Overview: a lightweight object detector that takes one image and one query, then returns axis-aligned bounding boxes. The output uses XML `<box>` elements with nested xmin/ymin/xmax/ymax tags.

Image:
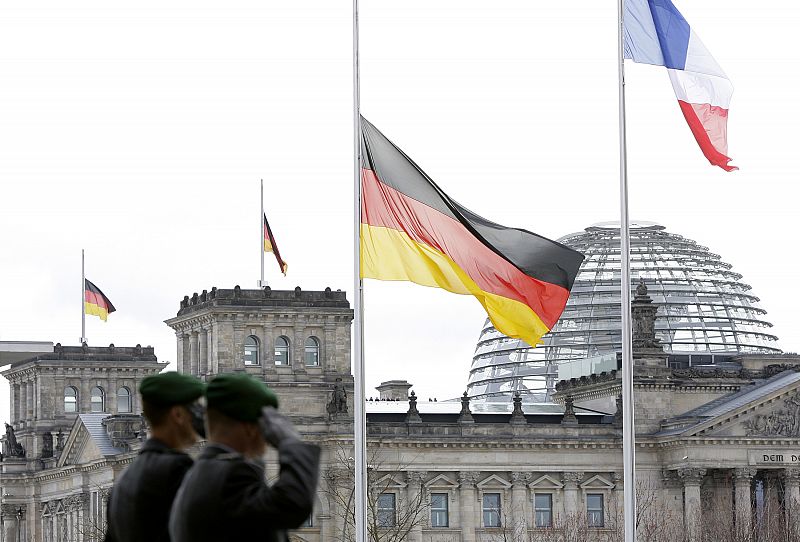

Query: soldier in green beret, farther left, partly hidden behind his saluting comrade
<box><xmin>105</xmin><ymin>372</ymin><xmax>205</xmax><ymax>542</ymax></box>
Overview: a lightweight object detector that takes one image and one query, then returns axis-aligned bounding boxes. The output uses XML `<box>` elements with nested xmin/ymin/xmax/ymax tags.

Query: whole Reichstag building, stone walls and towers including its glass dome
<box><xmin>0</xmin><ymin>223</ymin><xmax>800</xmax><ymax>542</ymax></box>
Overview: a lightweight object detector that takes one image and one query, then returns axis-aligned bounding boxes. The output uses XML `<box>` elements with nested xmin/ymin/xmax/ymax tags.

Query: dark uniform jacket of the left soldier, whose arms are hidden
<box><xmin>106</xmin><ymin>439</ymin><xmax>192</xmax><ymax>542</ymax></box>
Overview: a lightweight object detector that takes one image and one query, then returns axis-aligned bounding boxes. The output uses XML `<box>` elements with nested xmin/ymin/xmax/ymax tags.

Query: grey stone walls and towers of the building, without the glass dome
<box><xmin>7</xmin><ymin>287</ymin><xmax>800</xmax><ymax>542</ymax></box>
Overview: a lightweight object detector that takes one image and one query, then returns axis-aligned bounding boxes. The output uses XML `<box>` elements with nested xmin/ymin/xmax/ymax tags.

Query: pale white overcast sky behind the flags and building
<box><xmin>0</xmin><ymin>0</ymin><xmax>800</xmax><ymax>419</ymax></box>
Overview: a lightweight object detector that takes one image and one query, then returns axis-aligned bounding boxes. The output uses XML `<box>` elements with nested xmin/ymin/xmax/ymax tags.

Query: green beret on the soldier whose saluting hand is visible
<box><xmin>206</xmin><ymin>373</ymin><xmax>278</xmax><ymax>422</ymax></box>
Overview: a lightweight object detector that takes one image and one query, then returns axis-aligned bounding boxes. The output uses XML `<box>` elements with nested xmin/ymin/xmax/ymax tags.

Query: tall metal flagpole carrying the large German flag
<box><xmin>353</xmin><ymin>0</ymin><xmax>367</xmax><ymax>542</ymax></box>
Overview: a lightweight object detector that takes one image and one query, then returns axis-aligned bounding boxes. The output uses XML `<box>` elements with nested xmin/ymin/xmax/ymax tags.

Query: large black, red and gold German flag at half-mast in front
<box><xmin>361</xmin><ymin>117</ymin><xmax>583</xmax><ymax>346</ymax></box>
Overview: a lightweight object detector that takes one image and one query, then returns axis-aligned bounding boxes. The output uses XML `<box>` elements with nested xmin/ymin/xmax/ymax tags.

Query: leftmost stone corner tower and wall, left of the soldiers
<box><xmin>0</xmin><ymin>344</ymin><xmax>166</xmax><ymax>542</ymax></box>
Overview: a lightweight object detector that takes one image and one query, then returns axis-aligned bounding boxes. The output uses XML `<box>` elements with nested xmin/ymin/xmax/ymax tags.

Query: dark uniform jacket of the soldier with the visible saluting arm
<box><xmin>169</xmin><ymin>441</ymin><xmax>320</xmax><ymax>542</ymax></box>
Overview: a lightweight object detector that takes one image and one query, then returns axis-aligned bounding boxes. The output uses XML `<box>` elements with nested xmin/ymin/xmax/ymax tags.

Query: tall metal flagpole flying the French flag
<box><xmin>617</xmin><ymin>0</ymin><xmax>636</xmax><ymax>542</ymax></box>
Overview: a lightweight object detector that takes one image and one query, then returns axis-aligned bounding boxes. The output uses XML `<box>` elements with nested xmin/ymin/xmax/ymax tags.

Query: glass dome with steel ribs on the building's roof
<box><xmin>467</xmin><ymin>222</ymin><xmax>780</xmax><ymax>402</ymax></box>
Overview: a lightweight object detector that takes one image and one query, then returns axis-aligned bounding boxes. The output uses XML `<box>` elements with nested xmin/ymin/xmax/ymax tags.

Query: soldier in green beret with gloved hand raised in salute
<box><xmin>169</xmin><ymin>373</ymin><xmax>320</xmax><ymax>542</ymax></box>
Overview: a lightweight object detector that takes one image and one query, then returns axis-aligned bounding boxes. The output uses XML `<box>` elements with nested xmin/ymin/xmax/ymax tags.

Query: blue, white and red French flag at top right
<box><xmin>624</xmin><ymin>0</ymin><xmax>738</xmax><ymax>171</ymax></box>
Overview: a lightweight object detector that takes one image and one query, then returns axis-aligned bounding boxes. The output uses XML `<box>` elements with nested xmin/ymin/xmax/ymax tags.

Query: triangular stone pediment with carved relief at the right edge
<box><xmin>656</xmin><ymin>372</ymin><xmax>800</xmax><ymax>439</ymax></box>
